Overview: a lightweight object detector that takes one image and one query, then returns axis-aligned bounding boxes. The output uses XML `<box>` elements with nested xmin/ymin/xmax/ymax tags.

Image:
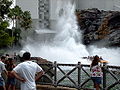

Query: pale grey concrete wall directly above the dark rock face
<box><xmin>77</xmin><ymin>0</ymin><xmax>120</xmax><ymax>10</ymax></box>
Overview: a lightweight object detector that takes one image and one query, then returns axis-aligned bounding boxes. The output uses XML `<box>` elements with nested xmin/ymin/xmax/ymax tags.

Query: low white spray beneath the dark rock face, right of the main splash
<box><xmin>88</xmin><ymin>45</ymin><xmax>120</xmax><ymax>66</ymax></box>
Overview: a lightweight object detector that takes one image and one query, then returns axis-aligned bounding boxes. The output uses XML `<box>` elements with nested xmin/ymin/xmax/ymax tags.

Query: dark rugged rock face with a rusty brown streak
<box><xmin>76</xmin><ymin>8</ymin><xmax>120</xmax><ymax>47</ymax></box>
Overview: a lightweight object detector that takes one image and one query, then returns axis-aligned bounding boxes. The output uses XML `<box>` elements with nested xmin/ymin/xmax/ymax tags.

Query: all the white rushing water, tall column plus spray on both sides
<box><xmin>23</xmin><ymin>0</ymin><xmax>120</xmax><ymax>65</ymax></box>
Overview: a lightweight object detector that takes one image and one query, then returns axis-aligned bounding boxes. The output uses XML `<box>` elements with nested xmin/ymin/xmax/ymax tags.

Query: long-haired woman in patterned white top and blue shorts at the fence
<box><xmin>90</xmin><ymin>55</ymin><xmax>103</xmax><ymax>90</ymax></box>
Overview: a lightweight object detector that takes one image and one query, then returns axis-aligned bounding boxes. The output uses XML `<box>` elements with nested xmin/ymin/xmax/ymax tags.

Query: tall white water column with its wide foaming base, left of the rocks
<box><xmin>23</xmin><ymin>0</ymin><xmax>89</xmax><ymax>63</ymax></box>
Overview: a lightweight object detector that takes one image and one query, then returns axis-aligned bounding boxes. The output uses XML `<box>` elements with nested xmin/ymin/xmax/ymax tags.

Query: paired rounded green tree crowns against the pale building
<box><xmin>8</xmin><ymin>6</ymin><xmax>32</xmax><ymax>30</ymax></box>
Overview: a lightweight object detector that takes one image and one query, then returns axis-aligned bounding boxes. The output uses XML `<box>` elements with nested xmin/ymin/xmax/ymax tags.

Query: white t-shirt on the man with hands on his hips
<box><xmin>17</xmin><ymin>61</ymin><xmax>42</xmax><ymax>90</ymax></box>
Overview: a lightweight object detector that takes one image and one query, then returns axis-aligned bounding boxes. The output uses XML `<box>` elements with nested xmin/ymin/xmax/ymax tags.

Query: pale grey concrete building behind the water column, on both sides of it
<box><xmin>16</xmin><ymin>0</ymin><xmax>120</xmax><ymax>29</ymax></box>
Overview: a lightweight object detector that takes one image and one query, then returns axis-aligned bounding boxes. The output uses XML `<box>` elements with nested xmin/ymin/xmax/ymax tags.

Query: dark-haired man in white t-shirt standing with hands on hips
<box><xmin>12</xmin><ymin>52</ymin><xmax>44</xmax><ymax>90</ymax></box>
